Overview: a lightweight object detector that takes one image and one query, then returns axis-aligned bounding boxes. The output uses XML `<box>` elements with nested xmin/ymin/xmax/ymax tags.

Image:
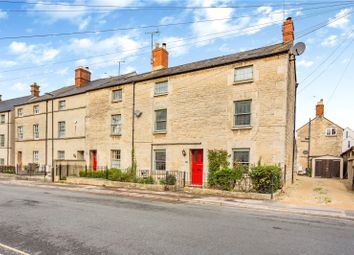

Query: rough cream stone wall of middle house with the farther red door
<box><xmin>86</xmin><ymin>85</ymin><xmax>133</xmax><ymax>168</ymax></box>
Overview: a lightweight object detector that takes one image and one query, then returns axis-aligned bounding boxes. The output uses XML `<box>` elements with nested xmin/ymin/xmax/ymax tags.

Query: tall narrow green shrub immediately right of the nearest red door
<box><xmin>208</xmin><ymin>150</ymin><xmax>229</xmax><ymax>187</ymax></box>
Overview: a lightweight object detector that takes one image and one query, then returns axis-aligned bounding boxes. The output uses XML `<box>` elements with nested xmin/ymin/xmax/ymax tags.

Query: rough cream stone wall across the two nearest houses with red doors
<box><xmin>86</xmin><ymin>54</ymin><xmax>295</xmax><ymax>183</ymax></box>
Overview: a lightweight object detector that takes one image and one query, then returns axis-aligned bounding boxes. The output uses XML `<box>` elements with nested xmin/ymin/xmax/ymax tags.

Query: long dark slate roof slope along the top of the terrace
<box><xmin>18</xmin><ymin>43</ymin><xmax>292</xmax><ymax>105</ymax></box>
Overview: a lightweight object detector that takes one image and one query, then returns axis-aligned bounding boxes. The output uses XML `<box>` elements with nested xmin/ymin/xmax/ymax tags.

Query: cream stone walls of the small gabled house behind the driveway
<box><xmin>297</xmin><ymin>117</ymin><xmax>343</xmax><ymax>169</ymax></box>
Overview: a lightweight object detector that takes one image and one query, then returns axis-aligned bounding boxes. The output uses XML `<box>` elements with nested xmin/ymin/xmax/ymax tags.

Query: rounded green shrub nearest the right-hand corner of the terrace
<box><xmin>250</xmin><ymin>165</ymin><xmax>281</xmax><ymax>193</ymax></box>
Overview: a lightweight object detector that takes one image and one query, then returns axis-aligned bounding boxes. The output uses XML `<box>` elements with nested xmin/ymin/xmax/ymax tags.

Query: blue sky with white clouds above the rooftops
<box><xmin>0</xmin><ymin>0</ymin><xmax>354</xmax><ymax>128</ymax></box>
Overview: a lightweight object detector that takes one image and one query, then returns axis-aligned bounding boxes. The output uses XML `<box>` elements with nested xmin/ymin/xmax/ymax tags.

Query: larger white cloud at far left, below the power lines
<box><xmin>9</xmin><ymin>41</ymin><xmax>60</xmax><ymax>64</ymax></box>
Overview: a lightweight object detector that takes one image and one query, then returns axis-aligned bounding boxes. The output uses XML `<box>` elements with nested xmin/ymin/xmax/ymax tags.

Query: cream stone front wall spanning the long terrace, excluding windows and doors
<box><xmin>11</xmin><ymin>51</ymin><xmax>295</xmax><ymax>183</ymax></box>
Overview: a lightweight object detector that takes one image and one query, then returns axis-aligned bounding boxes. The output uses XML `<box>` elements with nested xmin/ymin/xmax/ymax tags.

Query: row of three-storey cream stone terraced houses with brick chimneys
<box><xmin>0</xmin><ymin>18</ymin><xmax>296</xmax><ymax>185</ymax></box>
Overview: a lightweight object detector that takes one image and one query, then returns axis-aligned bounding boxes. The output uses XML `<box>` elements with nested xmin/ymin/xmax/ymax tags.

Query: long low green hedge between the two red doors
<box><xmin>79</xmin><ymin>169</ymin><xmax>155</xmax><ymax>184</ymax></box>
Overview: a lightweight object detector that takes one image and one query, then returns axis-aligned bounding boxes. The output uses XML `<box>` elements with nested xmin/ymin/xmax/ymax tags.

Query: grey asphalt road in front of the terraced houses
<box><xmin>0</xmin><ymin>184</ymin><xmax>354</xmax><ymax>255</ymax></box>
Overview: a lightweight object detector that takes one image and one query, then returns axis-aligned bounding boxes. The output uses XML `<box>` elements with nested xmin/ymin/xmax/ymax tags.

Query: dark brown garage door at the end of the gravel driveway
<box><xmin>315</xmin><ymin>159</ymin><xmax>340</xmax><ymax>178</ymax></box>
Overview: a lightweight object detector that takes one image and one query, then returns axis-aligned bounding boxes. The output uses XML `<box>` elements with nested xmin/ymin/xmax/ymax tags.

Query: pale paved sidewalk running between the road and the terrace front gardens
<box><xmin>0</xmin><ymin>179</ymin><xmax>354</xmax><ymax>220</ymax></box>
